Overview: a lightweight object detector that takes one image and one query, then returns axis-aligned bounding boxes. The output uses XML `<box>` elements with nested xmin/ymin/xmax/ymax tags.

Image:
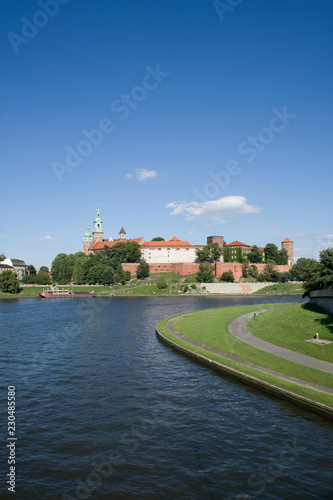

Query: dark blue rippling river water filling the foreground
<box><xmin>0</xmin><ymin>297</ymin><xmax>333</xmax><ymax>500</ymax></box>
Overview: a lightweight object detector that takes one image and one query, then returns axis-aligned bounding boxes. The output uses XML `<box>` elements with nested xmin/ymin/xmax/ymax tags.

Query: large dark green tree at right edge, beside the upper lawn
<box><xmin>303</xmin><ymin>248</ymin><xmax>333</xmax><ymax>295</ymax></box>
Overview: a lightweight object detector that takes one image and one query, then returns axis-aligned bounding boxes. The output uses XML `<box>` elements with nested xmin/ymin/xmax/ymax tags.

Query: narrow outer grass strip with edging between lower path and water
<box><xmin>156</xmin><ymin>311</ymin><xmax>333</xmax><ymax>420</ymax></box>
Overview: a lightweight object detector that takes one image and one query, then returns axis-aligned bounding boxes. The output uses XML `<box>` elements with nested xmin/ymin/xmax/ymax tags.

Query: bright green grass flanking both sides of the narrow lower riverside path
<box><xmin>157</xmin><ymin>304</ymin><xmax>333</xmax><ymax>407</ymax></box>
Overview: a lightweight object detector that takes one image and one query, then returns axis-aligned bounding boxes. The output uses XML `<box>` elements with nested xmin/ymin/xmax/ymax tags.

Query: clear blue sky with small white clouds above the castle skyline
<box><xmin>0</xmin><ymin>0</ymin><xmax>333</xmax><ymax>267</ymax></box>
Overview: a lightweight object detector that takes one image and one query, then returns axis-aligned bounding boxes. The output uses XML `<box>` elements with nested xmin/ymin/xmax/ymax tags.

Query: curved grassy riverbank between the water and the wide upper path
<box><xmin>157</xmin><ymin>304</ymin><xmax>333</xmax><ymax>419</ymax></box>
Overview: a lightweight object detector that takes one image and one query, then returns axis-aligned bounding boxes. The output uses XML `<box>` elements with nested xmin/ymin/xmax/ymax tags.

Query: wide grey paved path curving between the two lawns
<box><xmin>229</xmin><ymin>307</ymin><xmax>333</xmax><ymax>375</ymax></box>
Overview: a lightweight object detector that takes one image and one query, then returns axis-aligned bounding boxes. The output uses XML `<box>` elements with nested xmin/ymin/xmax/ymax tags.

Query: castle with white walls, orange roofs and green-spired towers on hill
<box><xmin>83</xmin><ymin>207</ymin><xmax>293</xmax><ymax>270</ymax></box>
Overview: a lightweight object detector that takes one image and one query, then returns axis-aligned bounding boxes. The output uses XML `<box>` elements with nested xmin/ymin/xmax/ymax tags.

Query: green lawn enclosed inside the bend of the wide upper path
<box><xmin>248</xmin><ymin>304</ymin><xmax>333</xmax><ymax>363</ymax></box>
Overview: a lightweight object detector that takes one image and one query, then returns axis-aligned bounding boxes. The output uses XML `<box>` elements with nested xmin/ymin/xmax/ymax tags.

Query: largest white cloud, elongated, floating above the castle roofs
<box><xmin>166</xmin><ymin>196</ymin><xmax>261</xmax><ymax>224</ymax></box>
